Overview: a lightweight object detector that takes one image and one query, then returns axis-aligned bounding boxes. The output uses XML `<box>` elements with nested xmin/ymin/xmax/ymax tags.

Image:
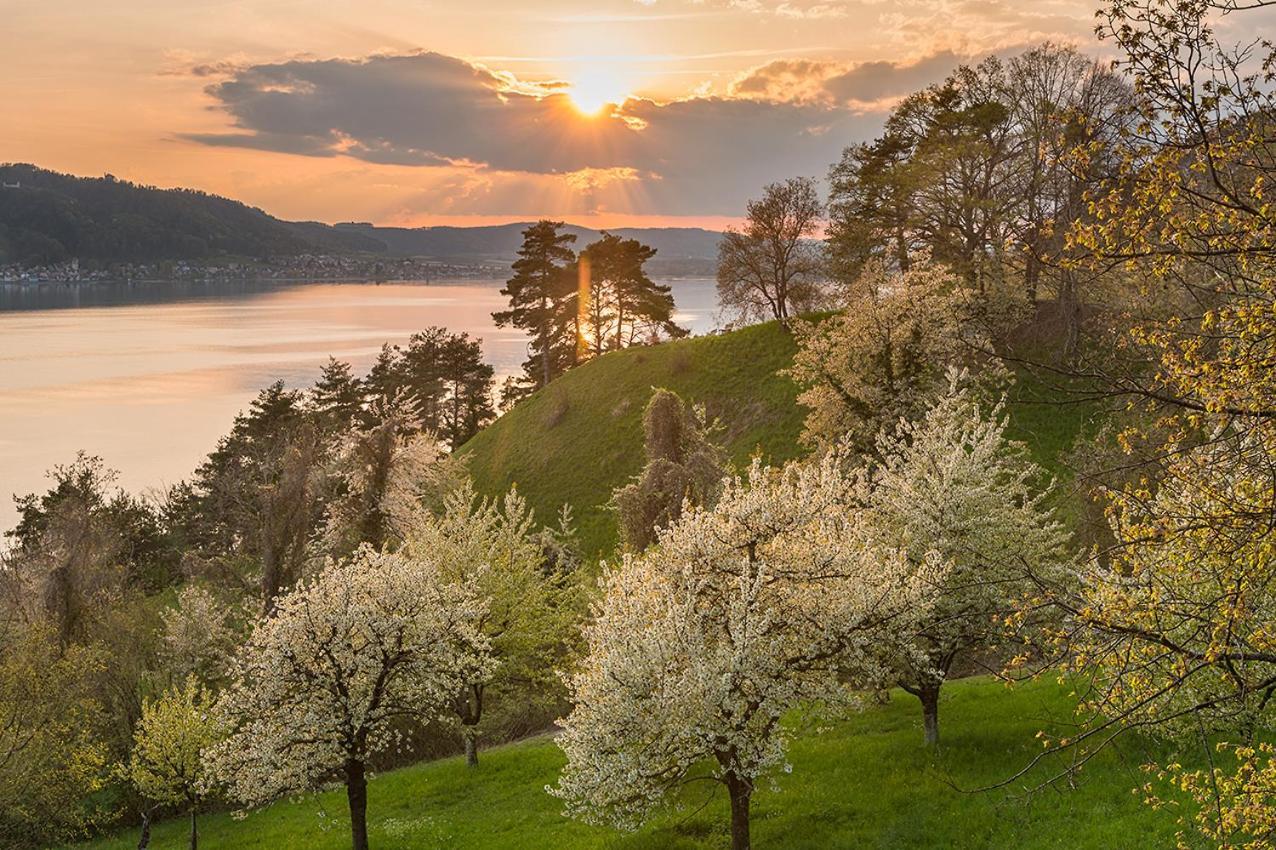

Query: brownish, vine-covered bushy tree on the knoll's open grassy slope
<box><xmin>611</xmin><ymin>389</ymin><xmax>726</xmax><ymax>551</ymax></box>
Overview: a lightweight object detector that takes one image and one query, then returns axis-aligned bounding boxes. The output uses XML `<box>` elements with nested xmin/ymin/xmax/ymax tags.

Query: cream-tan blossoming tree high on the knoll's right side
<box><xmin>790</xmin><ymin>260</ymin><xmax>997</xmax><ymax>452</ymax></box>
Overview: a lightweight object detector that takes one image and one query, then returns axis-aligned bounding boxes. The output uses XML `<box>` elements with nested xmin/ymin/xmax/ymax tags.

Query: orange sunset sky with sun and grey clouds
<box><xmin>0</xmin><ymin>0</ymin><xmax>1102</xmax><ymax>227</ymax></box>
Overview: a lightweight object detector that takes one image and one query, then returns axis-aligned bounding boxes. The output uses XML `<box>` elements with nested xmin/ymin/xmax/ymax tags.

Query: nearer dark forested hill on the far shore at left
<box><xmin>0</xmin><ymin>165</ymin><xmax>385</xmax><ymax>265</ymax></box>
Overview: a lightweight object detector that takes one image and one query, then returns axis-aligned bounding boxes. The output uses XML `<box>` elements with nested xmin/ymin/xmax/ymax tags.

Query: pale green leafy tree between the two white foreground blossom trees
<box><xmin>406</xmin><ymin>481</ymin><xmax>575</xmax><ymax>767</ymax></box>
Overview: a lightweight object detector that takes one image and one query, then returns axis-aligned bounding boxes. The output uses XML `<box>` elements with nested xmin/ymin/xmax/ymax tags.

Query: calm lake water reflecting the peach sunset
<box><xmin>0</xmin><ymin>281</ymin><xmax>716</xmax><ymax>528</ymax></box>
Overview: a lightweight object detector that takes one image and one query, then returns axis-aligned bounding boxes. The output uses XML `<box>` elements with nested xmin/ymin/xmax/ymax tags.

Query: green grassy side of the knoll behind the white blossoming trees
<box><xmin>462</xmin><ymin>317</ymin><xmax>1085</xmax><ymax>555</ymax></box>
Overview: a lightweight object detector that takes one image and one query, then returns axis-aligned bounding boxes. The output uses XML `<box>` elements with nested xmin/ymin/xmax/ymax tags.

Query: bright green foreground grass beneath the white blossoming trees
<box><xmin>69</xmin><ymin>679</ymin><xmax>1176</xmax><ymax>850</ymax></box>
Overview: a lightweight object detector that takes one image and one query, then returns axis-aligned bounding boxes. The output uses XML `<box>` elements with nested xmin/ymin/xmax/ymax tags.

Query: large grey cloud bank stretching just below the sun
<box><xmin>181</xmin><ymin>52</ymin><xmax>882</xmax><ymax>214</ymax></box>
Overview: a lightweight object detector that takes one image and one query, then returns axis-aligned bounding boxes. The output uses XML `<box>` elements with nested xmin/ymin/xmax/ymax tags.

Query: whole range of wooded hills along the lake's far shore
<box><xmin>0</xmin><ymin>163</ymin><xmax>718</xmax><ymax>274</ymax></box>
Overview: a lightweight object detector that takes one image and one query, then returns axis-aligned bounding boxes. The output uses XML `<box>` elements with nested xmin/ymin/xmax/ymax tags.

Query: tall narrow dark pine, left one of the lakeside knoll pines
<box><xmin>491</xmin><ymin>220</ymin><xmax>577</xmax><ymax>391</ymax></box>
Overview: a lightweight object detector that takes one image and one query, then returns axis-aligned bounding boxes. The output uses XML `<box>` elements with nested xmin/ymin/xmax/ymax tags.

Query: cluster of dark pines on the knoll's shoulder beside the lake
<box><xmin>493</xmin><ymin>220</ymin><xmax>686</xmax><ymax>402</ymax></box>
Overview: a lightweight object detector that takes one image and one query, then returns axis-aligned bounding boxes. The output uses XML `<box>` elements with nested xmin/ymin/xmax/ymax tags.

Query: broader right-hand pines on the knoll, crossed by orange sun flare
<box><xmin>577</xmin><ymin>234</ymin><xmax>686</xmax><ymax>357</ymax></box>
